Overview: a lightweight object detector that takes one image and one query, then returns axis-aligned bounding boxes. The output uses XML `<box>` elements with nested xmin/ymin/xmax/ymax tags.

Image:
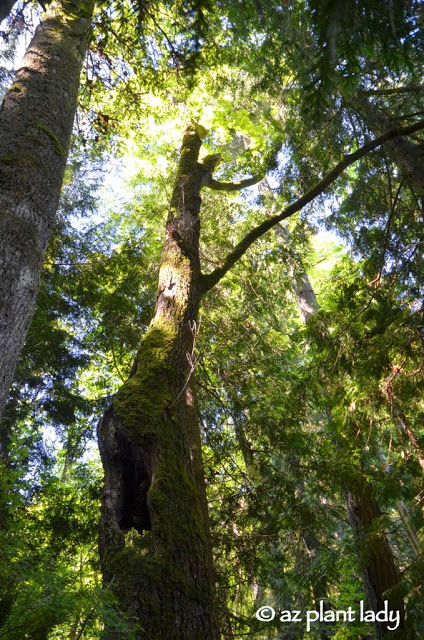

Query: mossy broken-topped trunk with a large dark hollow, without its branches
<box><xmin>98</xmin><ymin>125</ymin><xmax>219</xmax><ymax>640</ymax></box>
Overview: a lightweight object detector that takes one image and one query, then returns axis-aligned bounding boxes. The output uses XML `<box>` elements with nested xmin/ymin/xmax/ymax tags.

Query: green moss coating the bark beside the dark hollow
<box><xmin>109</xmin><ymin>317</ymin><xmax>210</xmax><ymax>601</ymax></box>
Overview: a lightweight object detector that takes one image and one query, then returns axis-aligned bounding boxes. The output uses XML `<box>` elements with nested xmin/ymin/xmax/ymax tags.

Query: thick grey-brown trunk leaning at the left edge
<box><xmin>0</xmin><ymin>0</ymin><xmax>93</xmax><ymax>416</ymax></box>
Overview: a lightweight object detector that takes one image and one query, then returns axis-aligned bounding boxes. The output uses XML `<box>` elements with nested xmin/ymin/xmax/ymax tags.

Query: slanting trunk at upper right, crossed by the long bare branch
<box><xmin>349</xmin><ymin>94</ymin><xmax>424</xmax><ymax>198</ymax></box>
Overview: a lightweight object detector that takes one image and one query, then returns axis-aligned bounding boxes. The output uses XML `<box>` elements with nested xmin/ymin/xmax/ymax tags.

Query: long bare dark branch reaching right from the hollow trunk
<box><xmin>201</xmin><ymin>120</ymin><xmax>424</xmax><ymax>294</ymax></box>
